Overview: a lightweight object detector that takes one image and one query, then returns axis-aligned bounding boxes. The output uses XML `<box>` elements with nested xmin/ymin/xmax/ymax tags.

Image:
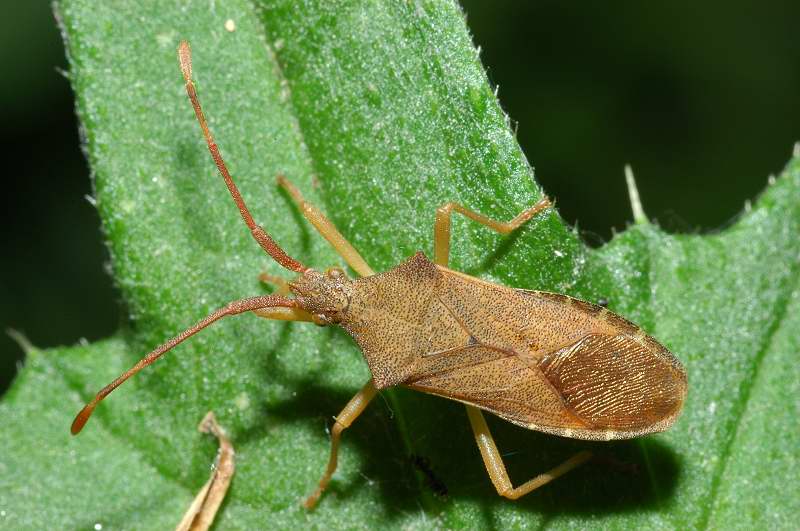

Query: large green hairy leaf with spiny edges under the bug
<box><xmin>0</xmin><ymin>0</ymin><xmax>800</xmax><ymax>529</ymax></box>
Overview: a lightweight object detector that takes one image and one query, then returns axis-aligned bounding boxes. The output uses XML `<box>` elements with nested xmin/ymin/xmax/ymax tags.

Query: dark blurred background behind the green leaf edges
<box><xmin>0</xmin><ymin>0</ymin><xmax>800</xmax><ymax>393</ymax></box>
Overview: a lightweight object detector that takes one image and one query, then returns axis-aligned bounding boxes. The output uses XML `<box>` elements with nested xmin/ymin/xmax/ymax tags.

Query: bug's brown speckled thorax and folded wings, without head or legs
<box><xmin>352</xmin><ymin>264</ymin><xmax>686</xmax><ymax>439</ymax></box>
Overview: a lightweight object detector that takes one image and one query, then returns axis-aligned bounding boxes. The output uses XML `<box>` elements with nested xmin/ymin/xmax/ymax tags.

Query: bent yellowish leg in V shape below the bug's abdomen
<box><xmin>467</xmin><ymin>406</ymin><xmax>592</xmax><ymax>500</ymax></box>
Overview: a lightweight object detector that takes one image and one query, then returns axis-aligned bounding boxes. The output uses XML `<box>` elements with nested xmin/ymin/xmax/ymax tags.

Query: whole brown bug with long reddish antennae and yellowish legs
<box><xmin>72</xmin><ymin>42</ymin><xmax>687</xmax><ymax>508</ymax></box>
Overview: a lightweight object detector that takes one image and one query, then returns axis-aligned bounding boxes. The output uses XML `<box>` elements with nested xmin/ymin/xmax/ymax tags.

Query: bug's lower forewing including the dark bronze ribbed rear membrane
<box><xmin>405</xmin><ymin>334</ymin><xmax>686</xmax><ymax>440</ymax></box>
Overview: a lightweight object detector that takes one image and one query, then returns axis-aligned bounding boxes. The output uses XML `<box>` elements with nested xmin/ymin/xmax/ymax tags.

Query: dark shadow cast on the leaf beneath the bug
<box><xmin>231</xmin><ymin>378</ymin><xmax>679</xmax><ymax>527</ymax></box>
